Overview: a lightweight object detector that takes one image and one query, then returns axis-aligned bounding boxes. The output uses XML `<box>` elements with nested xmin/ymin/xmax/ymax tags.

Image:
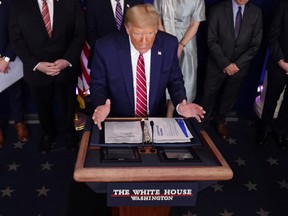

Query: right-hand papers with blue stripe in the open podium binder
<box><xmin>148</xmin><ymin>118</ymin><xmax>193</xmax><ymax>143</ymax></box>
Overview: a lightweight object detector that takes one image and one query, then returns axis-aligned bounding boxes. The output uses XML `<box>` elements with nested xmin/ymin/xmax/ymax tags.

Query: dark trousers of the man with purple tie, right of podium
<box><xmin>200</xmin><ymin>67</ymin><xmax>247</xmax><ymax>124</ymax></box>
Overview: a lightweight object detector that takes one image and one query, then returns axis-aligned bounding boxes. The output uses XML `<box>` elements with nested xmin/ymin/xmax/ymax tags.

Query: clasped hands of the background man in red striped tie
<box><xmin>37</xmin><ymin>59</ymin><xmax>69</xmax><ymax>76</ymax></box>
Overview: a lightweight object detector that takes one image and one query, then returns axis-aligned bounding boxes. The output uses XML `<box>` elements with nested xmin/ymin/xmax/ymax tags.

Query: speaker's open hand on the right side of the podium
<box><xmin>178</xmin><ymin>100</ymin><xmax>206</xmax><ymax>122</ymax></box>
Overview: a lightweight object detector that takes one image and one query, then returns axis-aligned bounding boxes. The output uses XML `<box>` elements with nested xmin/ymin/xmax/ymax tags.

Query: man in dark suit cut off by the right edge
<box><xmin>259</xmin><ymin>0</ymin><xmax>288</xmax><ymax>149</ymax></box>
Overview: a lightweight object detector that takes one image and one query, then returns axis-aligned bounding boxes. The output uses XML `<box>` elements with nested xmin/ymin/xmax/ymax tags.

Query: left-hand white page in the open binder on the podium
<box><xmin>105</xmin><ymin>121</ymin><xmax>142</xmax><ymax>143</ymax></box>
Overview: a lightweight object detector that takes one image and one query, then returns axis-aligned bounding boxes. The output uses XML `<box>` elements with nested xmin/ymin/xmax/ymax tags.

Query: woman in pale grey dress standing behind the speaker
<box><xmin>154</xmin><ymin>0</ymin><xmax>206</xmax><ymax>117</ymax></box>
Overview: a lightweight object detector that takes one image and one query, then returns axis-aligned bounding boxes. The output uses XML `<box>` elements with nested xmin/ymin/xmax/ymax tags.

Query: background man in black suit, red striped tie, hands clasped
<box><xmin>9</xmin><ymin>0</ymin><xmax>85</xmax><ymax>153</ymax></box>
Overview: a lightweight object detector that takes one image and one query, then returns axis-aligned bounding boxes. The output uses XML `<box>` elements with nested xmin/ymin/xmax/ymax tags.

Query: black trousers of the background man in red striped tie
<box><xmin>31</xmin><ymin>82</ymin><xmax>76</xmax><ymax>136</ymax></box>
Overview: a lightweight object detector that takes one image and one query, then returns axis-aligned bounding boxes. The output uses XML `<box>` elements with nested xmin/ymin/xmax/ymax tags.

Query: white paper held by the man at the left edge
<box><xmin>0</xmin><ymin>57</ymin><xmax>23</xmax><ymax>92</ymax></box>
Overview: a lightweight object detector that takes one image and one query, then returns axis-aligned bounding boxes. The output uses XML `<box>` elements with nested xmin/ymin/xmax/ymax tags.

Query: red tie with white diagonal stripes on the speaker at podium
<box><xmin>135</xmin><ymin>53</ymin><xmax>147</xmax><ymax>117</ymax></box>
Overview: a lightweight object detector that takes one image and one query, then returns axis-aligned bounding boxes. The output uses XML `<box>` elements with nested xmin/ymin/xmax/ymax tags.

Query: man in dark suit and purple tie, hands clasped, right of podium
<box><xmin>200</xmin><ymin>0</ymin><xmax>262</xmax><ymax>139</ymax></box>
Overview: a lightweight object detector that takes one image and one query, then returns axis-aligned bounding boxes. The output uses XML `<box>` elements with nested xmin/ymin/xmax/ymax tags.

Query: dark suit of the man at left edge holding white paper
<box><xmin>0</xmin><ymin>0</ymin><xmax>24</xmax><ymax>127</ymax></box>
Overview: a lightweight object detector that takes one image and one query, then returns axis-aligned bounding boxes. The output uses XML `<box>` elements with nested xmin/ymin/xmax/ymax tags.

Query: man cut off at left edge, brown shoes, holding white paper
<box><xmin>0</xmin><ymin>0</ymin><xmax>28</xmax><ymax>148</ymax></box>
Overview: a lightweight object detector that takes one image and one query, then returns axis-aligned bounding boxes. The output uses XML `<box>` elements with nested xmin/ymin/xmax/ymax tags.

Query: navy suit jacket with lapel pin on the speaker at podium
<box><xmin>90</xmin><ymin>31</ymin><xmax>186</xmax><ymax>117</ymax></box>
